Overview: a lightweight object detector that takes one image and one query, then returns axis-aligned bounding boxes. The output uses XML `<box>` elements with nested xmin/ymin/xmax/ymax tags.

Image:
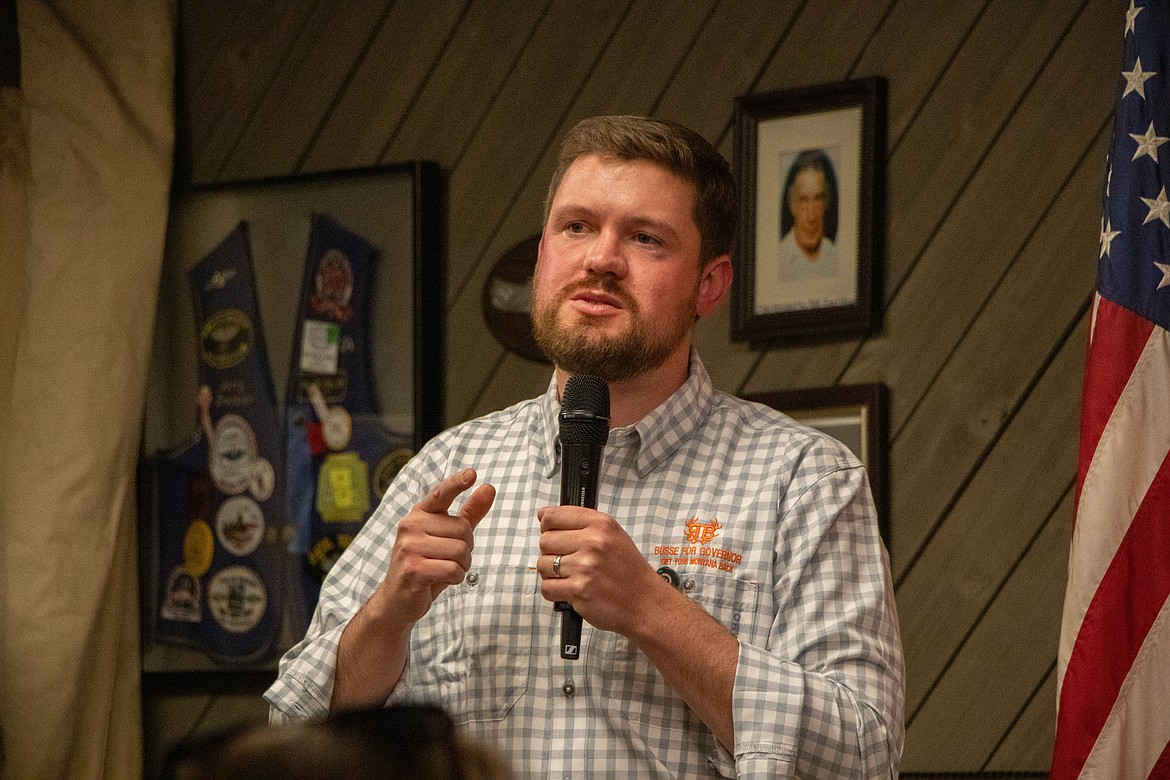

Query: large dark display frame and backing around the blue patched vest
<box><xmin>139</xmin><ymin>161</ymin><xmax>446</xmax><ymax>684</ymax></box>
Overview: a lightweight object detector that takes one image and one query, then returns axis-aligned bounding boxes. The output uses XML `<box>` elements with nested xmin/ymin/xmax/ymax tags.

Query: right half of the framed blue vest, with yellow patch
<box><xmin>285</xmin><ymin>214</ymin><xmax>413</xmax><ymax>635</ymax></box>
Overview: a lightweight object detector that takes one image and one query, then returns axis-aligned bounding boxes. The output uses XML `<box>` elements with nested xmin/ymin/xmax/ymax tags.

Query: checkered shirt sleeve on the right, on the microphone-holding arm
<box><xmin>732</xmin><ymin>448</ymin><xmax>904</xmax><ymax>778</ymax></box>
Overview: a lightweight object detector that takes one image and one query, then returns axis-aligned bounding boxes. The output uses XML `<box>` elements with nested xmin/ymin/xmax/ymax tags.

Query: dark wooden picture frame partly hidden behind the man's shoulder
<box><xmin>744</xmin><ymin>382</ymin><xmax>890</xmax><ymax>550</ymax></box>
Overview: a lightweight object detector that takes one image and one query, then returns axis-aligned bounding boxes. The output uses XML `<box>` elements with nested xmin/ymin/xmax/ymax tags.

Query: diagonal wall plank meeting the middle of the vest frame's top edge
<box><xmin>300</xmin><ymin>0</ymin><xmax>470</xmax><ymax>172</ymax></box>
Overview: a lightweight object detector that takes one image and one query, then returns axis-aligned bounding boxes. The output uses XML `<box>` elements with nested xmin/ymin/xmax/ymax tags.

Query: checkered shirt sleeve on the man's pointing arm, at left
<box><xmin>264</xmin><ymin>454</ymin><xmax>426</xmax><ymax>723</ymax></box>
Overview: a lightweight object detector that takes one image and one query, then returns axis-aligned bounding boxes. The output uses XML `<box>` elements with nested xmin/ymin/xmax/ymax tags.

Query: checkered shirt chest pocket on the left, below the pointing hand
<box><xmin>411</xmin><ymin>567</ymin><xmax>539</xmax><ymax>723</ymax></box>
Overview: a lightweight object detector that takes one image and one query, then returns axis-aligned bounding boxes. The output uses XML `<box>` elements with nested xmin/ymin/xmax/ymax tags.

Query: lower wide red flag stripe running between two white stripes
<box><xmin>1052</xmin><ymin>444</ymin><xmax>1170</xmax><ymax>778</ymax></box>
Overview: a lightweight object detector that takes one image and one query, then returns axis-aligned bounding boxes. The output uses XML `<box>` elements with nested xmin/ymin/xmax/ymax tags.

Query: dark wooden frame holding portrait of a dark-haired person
<box><xmin>731</xmin><ymin>77</ymin><xmax>886</xmax><ymax>345</ymax></box>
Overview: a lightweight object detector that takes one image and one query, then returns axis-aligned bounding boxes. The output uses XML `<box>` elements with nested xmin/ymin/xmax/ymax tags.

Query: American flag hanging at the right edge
<box><xmin>1051</xmin><ymin>0</ymin><xmax>1170</xmax><ymax>780</ymax></box>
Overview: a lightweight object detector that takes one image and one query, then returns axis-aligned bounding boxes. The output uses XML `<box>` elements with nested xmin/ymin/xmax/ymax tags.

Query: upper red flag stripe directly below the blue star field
<box><xmin>1076</xmin><ymin>298</ymin><xmax>1154</xmax><ymax>503</ymax></box>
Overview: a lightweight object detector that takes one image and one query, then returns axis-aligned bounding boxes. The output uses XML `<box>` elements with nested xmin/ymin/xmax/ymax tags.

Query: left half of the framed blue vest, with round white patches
<box><xmin>153</xmin><ymin>222</ymin><xmax>288</xmax><ymax>663</ymax></box>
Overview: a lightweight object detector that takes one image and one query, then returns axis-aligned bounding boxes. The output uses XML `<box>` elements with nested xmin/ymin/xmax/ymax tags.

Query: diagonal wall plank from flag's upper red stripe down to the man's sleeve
<box><xmin>892</xmin><ymin>317</ymin><xmax>1086</xmax><ymax>720</ymax></box>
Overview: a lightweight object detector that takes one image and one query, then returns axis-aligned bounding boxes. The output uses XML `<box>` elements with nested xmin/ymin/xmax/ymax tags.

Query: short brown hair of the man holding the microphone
<box><xmin>544</xmin><ymin>117</ymin><xmax>737</xmax><ymax>263</ymax></box>
